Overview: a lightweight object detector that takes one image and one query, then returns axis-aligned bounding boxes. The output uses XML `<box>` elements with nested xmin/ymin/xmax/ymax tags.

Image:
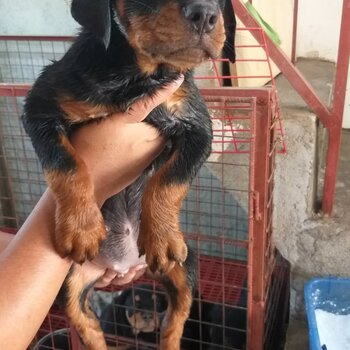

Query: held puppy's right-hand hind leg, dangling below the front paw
<box><xmin>160</xmin><ymin>250</ymin><xmax>196</xmax><ymax>350</ymax></box>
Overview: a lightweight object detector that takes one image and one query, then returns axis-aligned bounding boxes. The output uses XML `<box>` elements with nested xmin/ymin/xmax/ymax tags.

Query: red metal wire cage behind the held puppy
<box><xmin>0</xmin><ymin>28</ymin><xmax>289</xmax><ymax>350</ymax></box>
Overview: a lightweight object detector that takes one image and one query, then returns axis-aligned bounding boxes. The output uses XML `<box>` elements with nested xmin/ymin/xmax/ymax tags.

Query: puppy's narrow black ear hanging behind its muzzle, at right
<box><xmin>223</xmin><ymin>0</ymin><xmax>236</xmax><ymax>63</ymax></box>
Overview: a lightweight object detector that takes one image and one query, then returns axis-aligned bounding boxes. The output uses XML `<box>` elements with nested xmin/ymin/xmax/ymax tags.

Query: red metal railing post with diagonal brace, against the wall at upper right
<box><xmin>232</xmin><ymin>0</ymin><xmax>350</xmax><ymax>215</ymax></box>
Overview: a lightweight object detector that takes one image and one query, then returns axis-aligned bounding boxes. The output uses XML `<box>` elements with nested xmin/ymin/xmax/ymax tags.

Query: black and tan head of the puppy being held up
<box><xmin>72</xmin><ymin>0</ymin><xmax>234</xmax><ymax>73</ymax></box>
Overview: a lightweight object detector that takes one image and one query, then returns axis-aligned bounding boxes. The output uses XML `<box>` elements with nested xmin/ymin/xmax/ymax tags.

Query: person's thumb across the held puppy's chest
<box><xmin>127</xmin><ymin>75</ymin><xmax>184</xmax><ymax>122</ymax></box>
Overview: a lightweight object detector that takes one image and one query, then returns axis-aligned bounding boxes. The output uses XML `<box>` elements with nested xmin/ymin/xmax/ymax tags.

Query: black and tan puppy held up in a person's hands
<box><xmin>23</xmin><ymin>0</ymin><xmax>234</xmax><ymax>350</ymax></box>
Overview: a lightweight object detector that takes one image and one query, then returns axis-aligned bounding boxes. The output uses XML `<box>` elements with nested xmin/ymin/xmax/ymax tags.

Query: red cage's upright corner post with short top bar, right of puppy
<box><xmin>201</xmin><ymin>88</ymin><xmax>276</xmax><ymax>350</ymax></box>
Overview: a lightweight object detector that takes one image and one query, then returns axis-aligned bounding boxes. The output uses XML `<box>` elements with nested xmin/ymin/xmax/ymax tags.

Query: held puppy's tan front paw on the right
<box><xmin>137</xmin><ymin>230</ymin><xmax>187</xmax><ymax>274</ymax></box>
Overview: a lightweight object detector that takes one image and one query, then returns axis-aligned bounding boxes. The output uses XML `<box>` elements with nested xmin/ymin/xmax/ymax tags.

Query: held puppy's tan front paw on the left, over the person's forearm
<box><xmin>55</xmin><ymin>204</ymin><xmax>106</xmax><ymax>264</ymax></box>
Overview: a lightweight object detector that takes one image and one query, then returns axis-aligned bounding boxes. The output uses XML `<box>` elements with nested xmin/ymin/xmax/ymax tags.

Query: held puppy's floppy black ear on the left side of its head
<box><xmin>71</xmin><ymin>0</ymin><xmax>111</xmax><ymax>49</ymax></box>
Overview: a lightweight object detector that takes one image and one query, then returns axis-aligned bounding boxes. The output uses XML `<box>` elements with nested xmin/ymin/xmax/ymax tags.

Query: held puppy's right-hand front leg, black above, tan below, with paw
<box><xmin>138</xmin><ymin>102</ymin><xmax>212</xmax><ymax>273</ymax></box>
